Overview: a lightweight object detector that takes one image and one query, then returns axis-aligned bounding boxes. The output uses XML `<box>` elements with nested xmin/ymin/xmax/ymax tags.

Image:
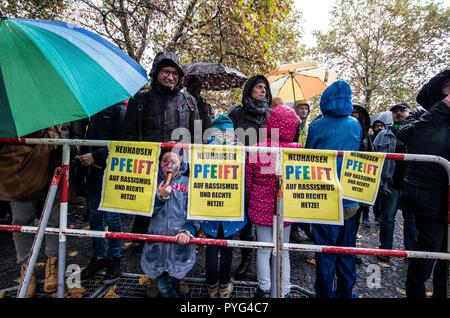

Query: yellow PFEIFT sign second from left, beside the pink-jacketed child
<box><xmin>187</xmin><ymin>144</ymin><xmax>245</xmax><ymax>221</ymax></box>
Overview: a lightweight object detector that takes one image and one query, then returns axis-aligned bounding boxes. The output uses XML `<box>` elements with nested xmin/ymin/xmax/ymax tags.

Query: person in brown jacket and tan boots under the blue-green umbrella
<box><xmin>0</xmin><ymin>124</ymin><xmax>70</xmax><ymax>298</ymax></box>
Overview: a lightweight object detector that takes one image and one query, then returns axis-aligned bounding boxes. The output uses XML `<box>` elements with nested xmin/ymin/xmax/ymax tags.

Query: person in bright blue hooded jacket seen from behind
<box><xmin>306</xmin><ymin>80</ymin><xmax>362</xmax><ymax>298</ymax></box>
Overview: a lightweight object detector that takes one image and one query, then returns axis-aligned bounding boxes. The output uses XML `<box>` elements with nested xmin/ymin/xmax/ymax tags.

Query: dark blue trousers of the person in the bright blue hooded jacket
<box><xmin>312</xmin><ymin>216</ymin><xmax>356</xmax><ymax>298</ymax></box>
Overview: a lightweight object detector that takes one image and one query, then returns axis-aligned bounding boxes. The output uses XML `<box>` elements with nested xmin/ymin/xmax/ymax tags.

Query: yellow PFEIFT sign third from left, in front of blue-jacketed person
<box><xmin>282</xmin><ymin>149</ymin><xmax>344</xmax><ymax>224</ymax></box>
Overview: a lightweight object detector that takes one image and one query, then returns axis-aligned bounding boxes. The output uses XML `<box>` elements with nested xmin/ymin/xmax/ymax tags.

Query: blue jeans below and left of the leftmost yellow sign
<box><xmin>86</xmin><ymin>190</ymin><xmax>122</xmax><ymax>257</ymax></box>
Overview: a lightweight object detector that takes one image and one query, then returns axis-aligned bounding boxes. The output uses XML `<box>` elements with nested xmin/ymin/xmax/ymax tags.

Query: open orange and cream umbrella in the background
<box><xmin>266</xmin><ymin>62</ymin><xmax>337</xmax><ymax>104</ymax></box>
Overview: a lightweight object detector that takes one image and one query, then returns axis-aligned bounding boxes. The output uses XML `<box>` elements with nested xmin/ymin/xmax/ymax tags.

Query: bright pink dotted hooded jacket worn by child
<box><xmin>245</xmin><ymin>105</ymin><xmax>301</xmax><ymax>226</ymax></box>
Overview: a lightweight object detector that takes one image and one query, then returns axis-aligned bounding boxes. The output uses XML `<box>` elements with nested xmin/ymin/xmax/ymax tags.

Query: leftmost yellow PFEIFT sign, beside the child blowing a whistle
<box><xmin>99</xmin><ymin>141</ymin><xmax>159</xmax><ymax>216</ymax></box>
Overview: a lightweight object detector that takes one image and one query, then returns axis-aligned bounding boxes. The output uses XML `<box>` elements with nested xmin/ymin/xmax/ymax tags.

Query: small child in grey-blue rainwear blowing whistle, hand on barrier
<box><xmin>141</xmin><ymin>150</ymin><xmax>199</xmax><ymax>298</ymax></box>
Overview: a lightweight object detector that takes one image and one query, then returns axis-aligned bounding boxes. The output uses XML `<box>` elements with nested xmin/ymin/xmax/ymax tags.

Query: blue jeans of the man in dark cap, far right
<box><xmin>380</xmin><ymin>185</ymin><xmax>417</xmax><ymax>250</ymax></box>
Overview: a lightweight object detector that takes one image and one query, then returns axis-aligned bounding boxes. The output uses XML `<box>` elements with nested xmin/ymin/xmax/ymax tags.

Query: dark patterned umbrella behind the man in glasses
<box><xmin>184</xmin><ymin>62</ymin><xmax>247</xmax><ymax>91</ymax></box>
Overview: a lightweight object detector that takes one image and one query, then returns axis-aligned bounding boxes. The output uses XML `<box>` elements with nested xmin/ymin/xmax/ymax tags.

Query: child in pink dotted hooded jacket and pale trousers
<box><xmin>245</xmin><ymin>105</ymin><xmax>301</xmax><ymax>298</ymax></box>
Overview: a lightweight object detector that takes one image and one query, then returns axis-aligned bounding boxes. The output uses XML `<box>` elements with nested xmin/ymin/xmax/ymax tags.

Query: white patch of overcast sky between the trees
<box><xmin>295</xmin><ymin>0</ymin><xmax>450</xmax><ymax>47</ymax></box>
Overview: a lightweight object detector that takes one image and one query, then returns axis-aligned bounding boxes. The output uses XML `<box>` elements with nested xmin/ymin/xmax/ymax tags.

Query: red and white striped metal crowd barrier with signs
<box><xmin>0</xmin><ymin>138</ymin><xmax>450</xmax><ymax>298</ymax></box>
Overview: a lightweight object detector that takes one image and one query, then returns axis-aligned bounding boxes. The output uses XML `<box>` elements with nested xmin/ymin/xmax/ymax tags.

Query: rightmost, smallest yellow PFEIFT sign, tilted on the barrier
<box><xmin>341</xmin><ymin>152</ymin><xmax>384</xmax><ymax>205</ymax></box>
